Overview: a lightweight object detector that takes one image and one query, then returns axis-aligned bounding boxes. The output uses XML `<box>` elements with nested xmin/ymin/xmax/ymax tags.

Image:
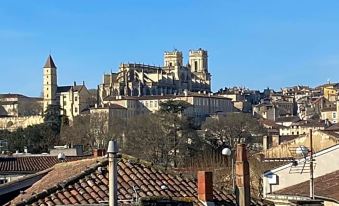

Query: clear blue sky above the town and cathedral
<box><xmin>0</xmin><ymin>0</ymin><xmax>339</xmax><ymax>96</ymax></box>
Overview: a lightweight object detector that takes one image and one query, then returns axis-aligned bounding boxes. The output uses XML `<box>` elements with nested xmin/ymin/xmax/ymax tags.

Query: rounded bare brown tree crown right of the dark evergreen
<box><xmin>202</xmin><ymin>112</ymin><xmax>263</xmax><ymax>148</ymax></box>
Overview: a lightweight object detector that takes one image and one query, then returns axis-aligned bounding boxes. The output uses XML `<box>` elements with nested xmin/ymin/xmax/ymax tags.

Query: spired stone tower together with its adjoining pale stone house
<box><xmin>43</xmin><ymin>55</ymin><xmax>90</xmax><ymax>121</ymax></box>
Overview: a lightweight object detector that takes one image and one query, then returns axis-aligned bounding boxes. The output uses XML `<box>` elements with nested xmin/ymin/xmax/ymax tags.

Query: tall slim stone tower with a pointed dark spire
<box><xmin>43</xmin><ymin>55</ymin><xmax>58</xmax><ymax>111</ymax></box>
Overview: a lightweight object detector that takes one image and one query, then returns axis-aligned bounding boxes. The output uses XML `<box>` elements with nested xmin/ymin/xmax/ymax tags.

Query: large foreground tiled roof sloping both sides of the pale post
<box><xmin>12</xmin><ymin>157</ymin><xmax>270</xmax><ymax>205</ymax></box>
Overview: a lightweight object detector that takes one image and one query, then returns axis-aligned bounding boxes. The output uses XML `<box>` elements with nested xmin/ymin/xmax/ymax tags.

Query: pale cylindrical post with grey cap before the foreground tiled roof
<box><xmin>107</xmin><ymin>140</ymin><xmax>119</xmax><ymax>206</ymax></box>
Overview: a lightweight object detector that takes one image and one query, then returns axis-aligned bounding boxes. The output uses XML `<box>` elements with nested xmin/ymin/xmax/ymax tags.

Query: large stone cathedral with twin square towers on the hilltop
<box><xmin>98</xmin><ymin>49</ymin><xmax>211</xmax><ymax>101</ymax></box>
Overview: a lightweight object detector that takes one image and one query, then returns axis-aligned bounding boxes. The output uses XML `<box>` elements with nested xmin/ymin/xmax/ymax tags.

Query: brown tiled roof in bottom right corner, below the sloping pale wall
<box><xmin>274</xmin><ymin>170</ymin><xmax>339</xmax><ymax>201</ymax></box>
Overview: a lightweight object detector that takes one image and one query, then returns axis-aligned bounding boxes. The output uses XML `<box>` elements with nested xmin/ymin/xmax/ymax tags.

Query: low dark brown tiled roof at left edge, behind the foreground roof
<box><xmin>0</xmin><ymin>155</ymin><xmax>89</xmax><ymax>174</ymax></box>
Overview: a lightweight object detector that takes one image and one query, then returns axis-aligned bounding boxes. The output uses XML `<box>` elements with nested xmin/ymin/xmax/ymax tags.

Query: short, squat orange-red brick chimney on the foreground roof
<box><xmin>198</xmin><ymin>171</ymin><xmax>213</xmax><ymax>203</ymax></box>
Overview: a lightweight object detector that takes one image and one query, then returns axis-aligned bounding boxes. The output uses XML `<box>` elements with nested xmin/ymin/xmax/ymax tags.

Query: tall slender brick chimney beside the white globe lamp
<box><xmin>235</xmin><ymin>144</ymin><xmax>251</xmax><ymax>206</ymax></box>
